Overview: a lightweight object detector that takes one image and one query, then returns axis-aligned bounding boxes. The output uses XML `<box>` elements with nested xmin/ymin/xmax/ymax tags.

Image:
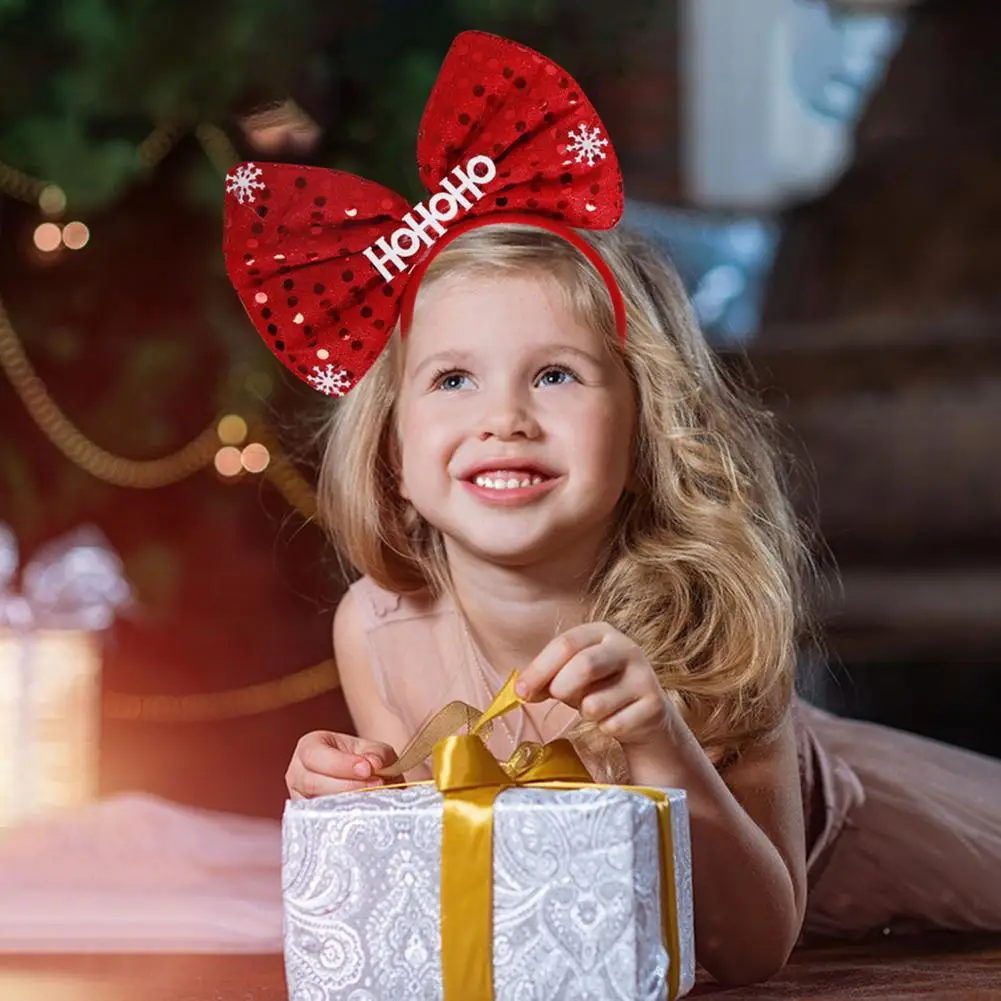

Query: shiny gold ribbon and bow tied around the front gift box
<box><xmin>376</xmin><ymin>672</ymin><xmax>681</xmax><ymax>1001</ymax></box>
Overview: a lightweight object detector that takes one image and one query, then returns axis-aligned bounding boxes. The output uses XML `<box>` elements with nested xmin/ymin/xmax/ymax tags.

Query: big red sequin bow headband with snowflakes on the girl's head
<box><xmin>223</xmin><ymin>31</ymin><xmax>626</xmax><ymax>396</ymax></box>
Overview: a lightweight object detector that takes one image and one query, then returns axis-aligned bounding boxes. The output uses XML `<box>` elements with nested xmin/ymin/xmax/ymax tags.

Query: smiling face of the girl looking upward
<box><xmin>396</xmin><ymin>275</ymin><xmax>636</xmax><ymax>571</ymax></box>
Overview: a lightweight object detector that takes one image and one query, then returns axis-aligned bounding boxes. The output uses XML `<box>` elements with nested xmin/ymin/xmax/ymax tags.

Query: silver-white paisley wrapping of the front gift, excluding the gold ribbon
<box><xmin>282</xmin><ymin>785</ymin><xmax>695</xmax><ymax>1001</ymax></box>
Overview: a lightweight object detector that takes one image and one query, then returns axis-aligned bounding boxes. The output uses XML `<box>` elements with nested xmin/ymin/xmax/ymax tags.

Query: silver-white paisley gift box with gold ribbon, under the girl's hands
<box><xmin>282</xmin><ymin>672</ymin><xmax>695</xmax><ymax>1001</ymax></box>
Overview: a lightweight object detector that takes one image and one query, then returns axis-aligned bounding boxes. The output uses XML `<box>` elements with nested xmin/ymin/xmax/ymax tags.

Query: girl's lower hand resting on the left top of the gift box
<box><xmin>285</xmin><ymin>730</ymin><xmax>396</xmax><ymax>800</ymax></box>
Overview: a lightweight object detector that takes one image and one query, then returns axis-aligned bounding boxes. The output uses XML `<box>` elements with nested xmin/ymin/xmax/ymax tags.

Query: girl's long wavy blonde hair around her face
<box><xmin>318</xmin><ymin>223</ymin><xmax>809</xmax><ymax>766</ymax></box>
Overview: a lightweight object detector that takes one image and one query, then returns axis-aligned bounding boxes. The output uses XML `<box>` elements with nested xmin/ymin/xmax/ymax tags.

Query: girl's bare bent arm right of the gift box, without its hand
<box><xmin>624</xmin><ymin>714</ymin><xmax>807</xmax><ymax>986</ymax></box>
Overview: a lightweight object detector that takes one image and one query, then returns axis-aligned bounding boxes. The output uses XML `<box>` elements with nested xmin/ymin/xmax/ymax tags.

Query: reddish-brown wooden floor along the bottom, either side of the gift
<box><xmin>0</xmin><ymin>936</ymin><xmax>1001</xmax><ymax>1001</ymax></box>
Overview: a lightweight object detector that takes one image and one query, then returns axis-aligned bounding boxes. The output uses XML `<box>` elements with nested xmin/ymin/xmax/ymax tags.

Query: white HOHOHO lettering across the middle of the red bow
<box><xmin>364</xmin><ymin>156</ymin><xmax>497</xmax><ymax>281</ymax></box>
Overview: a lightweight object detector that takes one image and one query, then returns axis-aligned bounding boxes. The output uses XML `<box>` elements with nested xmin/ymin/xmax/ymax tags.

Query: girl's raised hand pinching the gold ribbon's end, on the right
<box><xmin>516</xmin><ymin>623</ymin><xmax>676</xmax><ymax>745</ymax></box>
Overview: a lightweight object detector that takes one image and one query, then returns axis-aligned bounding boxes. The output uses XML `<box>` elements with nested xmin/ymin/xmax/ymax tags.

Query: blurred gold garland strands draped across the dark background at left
<box><xmin>0</xmin><ymin>124</ymin><xmax>332</xmax><ymax>723</ymax></box>
